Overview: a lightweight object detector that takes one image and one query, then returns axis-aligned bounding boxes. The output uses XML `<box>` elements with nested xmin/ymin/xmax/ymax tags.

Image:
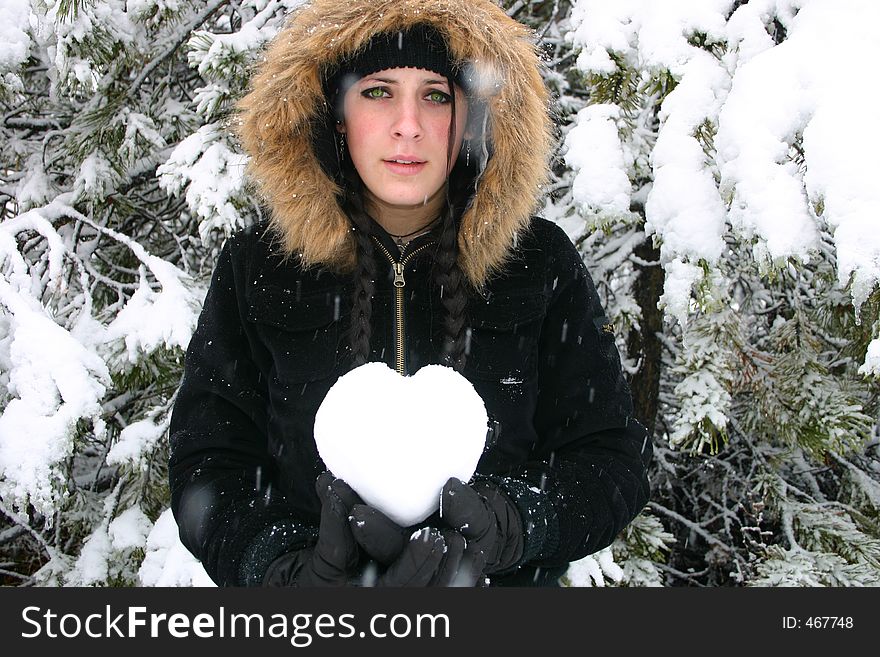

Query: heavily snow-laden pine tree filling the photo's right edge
<box><xmin>566</xmin><ymin>0</ymin><xmax>880</xmax><ymax>585</ymax></box>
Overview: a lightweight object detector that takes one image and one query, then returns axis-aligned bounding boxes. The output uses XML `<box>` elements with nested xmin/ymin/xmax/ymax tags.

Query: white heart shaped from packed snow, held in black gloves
<box><xmin>315</xmin><ymin>363</ymin><xmax>488</xmax><ymax>527</ymax></box>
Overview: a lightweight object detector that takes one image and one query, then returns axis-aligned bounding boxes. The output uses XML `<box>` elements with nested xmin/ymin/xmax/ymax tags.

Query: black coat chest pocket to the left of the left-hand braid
<box><xmin>248</xmin><ymin>286</ymin><xmax>342</xmax><ymax>383</ymax></box>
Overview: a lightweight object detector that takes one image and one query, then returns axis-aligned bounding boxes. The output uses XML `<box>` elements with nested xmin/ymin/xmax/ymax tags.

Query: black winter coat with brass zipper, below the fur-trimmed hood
<box><xmin>170</xmin><ymin>219</ymin><xmax>651</xmax><ymax>585</ymax></box>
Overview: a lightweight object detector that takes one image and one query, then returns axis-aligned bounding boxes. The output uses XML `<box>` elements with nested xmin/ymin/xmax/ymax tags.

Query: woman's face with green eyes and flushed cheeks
<box><xmin>339</xmin><ymin>68</ymin><xmax>467</xmax><ymax>217</ymax></box>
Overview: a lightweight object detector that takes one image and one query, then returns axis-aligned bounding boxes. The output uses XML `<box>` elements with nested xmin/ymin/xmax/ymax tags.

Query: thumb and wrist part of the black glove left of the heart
<box><xmin>263</xmin><ymin>472</ymin><xmax>361</xmax><ymax>586</ymax></box>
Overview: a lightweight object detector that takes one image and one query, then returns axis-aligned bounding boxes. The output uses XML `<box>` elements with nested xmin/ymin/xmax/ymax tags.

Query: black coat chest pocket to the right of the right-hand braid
<box><xmin>465</xmin><ymin>294</ymin><xmax>545</xmax><ymax>383</ymax></box>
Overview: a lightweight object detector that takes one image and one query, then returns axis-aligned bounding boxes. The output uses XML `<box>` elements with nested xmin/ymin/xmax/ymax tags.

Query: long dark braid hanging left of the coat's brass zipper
<box><xmin>343</xmin><ymin>182</ymin><xmax>376</xmax><ymax>368</ymax></box>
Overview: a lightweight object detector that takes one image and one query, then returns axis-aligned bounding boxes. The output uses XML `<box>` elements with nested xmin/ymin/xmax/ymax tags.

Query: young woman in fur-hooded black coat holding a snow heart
<box><xmin>170</xmin><ymin>0</ymin><xmax>651</xmax><ymax>586</ymax></box>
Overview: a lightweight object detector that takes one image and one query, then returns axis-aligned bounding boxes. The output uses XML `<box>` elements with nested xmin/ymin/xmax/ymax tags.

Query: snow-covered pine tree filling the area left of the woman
<box><xmin>0</xmin><ymin>0</ymin><xmax>298</xmax><ymax>585</ymax></box>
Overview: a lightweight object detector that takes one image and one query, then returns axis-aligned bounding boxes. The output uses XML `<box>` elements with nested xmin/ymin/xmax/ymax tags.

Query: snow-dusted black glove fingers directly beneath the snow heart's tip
<box><xmin>350</xmin><ymin>504</ymin><xmax>485</xmax><ymax>587</ymax></box>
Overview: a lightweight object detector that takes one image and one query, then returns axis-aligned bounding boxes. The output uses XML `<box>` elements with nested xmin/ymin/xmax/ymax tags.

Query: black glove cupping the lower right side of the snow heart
<box><xmin>440</xmin><ymin>477</ymin><xmax>525</xmax><ymax>574</ymax></box>
